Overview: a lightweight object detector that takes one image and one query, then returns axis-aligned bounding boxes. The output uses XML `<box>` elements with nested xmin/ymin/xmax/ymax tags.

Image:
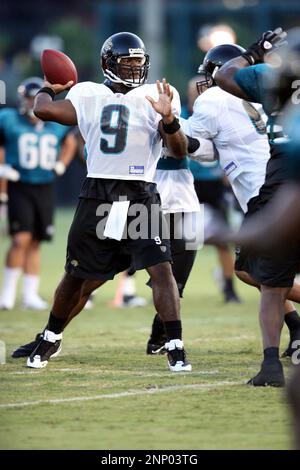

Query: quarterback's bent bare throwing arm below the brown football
<box><xmin>33</xmin><ymin>81</ymin><xmax>77</xmax><ymax>126</ymax></box>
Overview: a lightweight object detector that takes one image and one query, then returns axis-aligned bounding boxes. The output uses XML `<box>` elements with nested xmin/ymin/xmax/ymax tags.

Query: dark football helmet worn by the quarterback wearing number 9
<box><xmin>101</xmin><ymin>32</ymin><xmax>150</xmax><ymax>88</ymax></box>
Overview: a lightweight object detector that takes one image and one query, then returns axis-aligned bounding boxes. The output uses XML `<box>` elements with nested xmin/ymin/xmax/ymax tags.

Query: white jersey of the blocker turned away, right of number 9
<box><xmin>181</xmin><ymin>87</ymin><xmax>270</xmax><ymax>212</ymax></box>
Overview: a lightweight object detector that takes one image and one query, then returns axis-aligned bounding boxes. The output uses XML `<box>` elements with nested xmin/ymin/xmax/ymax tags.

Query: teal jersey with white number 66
<box><xmin>0</xmin><ymin>108</ymin><xmax>70</xmax><ymax>184</ymax></box>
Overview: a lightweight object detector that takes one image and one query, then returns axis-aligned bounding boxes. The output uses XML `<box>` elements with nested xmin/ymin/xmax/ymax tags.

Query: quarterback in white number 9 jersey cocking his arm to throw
<box><xmin>15</xmin><ymin>32</ymin><xmax>191</xmax><ymax>372</ymax></box>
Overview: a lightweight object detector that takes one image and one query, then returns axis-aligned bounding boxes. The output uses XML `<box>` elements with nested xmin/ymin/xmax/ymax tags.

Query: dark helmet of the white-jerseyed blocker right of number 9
<box><xmin>196</xmin><ymin>44</ymin><xmax>245</xmax><ymax>94</ymax></box>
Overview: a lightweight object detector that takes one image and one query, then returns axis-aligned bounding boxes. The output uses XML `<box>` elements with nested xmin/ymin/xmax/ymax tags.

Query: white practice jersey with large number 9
<box><xmin>66</xmin><ymin>82</ymin><xmax>181</xmax><ymax>182</ymax></box>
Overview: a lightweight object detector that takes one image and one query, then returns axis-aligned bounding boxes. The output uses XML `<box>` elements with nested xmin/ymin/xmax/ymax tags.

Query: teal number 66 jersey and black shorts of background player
<box><xmin>0</xmin><ymin>108</ymin><xmax>70</xmax><ymax>240</ymax></box>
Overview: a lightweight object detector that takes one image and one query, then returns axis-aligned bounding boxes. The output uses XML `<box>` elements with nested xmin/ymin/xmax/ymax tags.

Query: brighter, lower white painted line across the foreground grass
<box><xmin>0</xmin><ymin>381</ymin><xmax>239</xmax><ymax>409</ymax></box>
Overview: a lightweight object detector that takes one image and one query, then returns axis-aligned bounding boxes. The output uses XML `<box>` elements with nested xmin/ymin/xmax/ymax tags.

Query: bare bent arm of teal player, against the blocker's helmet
<box><xmin>214</xmin><ymin>56</ymin><xmax>249</xmax><ymax>99</ymax></box>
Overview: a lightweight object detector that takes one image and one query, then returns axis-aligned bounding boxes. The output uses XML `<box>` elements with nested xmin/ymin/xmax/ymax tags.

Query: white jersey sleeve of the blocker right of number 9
<box><xmin>180</xmin><ymin>94</ymin><xmax>220</xmax><ymax>139</ymax></box>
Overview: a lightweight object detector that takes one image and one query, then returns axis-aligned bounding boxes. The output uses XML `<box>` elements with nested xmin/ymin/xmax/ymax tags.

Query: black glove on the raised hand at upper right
<box><xmin>242</xmin><ymin>28</ymin><xmax>287</xmax><ymax>65</ymax></box>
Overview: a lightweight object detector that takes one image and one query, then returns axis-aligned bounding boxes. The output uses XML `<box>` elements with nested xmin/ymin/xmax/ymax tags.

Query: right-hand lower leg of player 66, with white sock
<box><xmin>23</xmin><ymin>240</ymin><xmax>48</xmax><ymax>310</ymax></box>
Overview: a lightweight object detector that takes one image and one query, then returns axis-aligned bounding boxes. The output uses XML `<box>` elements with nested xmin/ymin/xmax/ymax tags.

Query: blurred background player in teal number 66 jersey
<box><xmin>0</xmin><ymin>77</ymin><xmax>76</xmax><ymax>310</ymax></box>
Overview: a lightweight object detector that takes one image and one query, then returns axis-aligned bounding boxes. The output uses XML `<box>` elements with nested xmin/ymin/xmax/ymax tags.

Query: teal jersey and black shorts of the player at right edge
<box><xmin>234</xmin><ymin>64</ymin><xmax>300</xmax><ymax>287</ymax></box>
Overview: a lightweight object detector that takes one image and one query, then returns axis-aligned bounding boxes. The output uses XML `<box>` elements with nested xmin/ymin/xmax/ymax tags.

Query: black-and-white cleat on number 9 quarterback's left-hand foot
<box><xmin>27</xmin><ymin>330</ymin><xmax>62</xmax><ymax>369</ymax></box>
